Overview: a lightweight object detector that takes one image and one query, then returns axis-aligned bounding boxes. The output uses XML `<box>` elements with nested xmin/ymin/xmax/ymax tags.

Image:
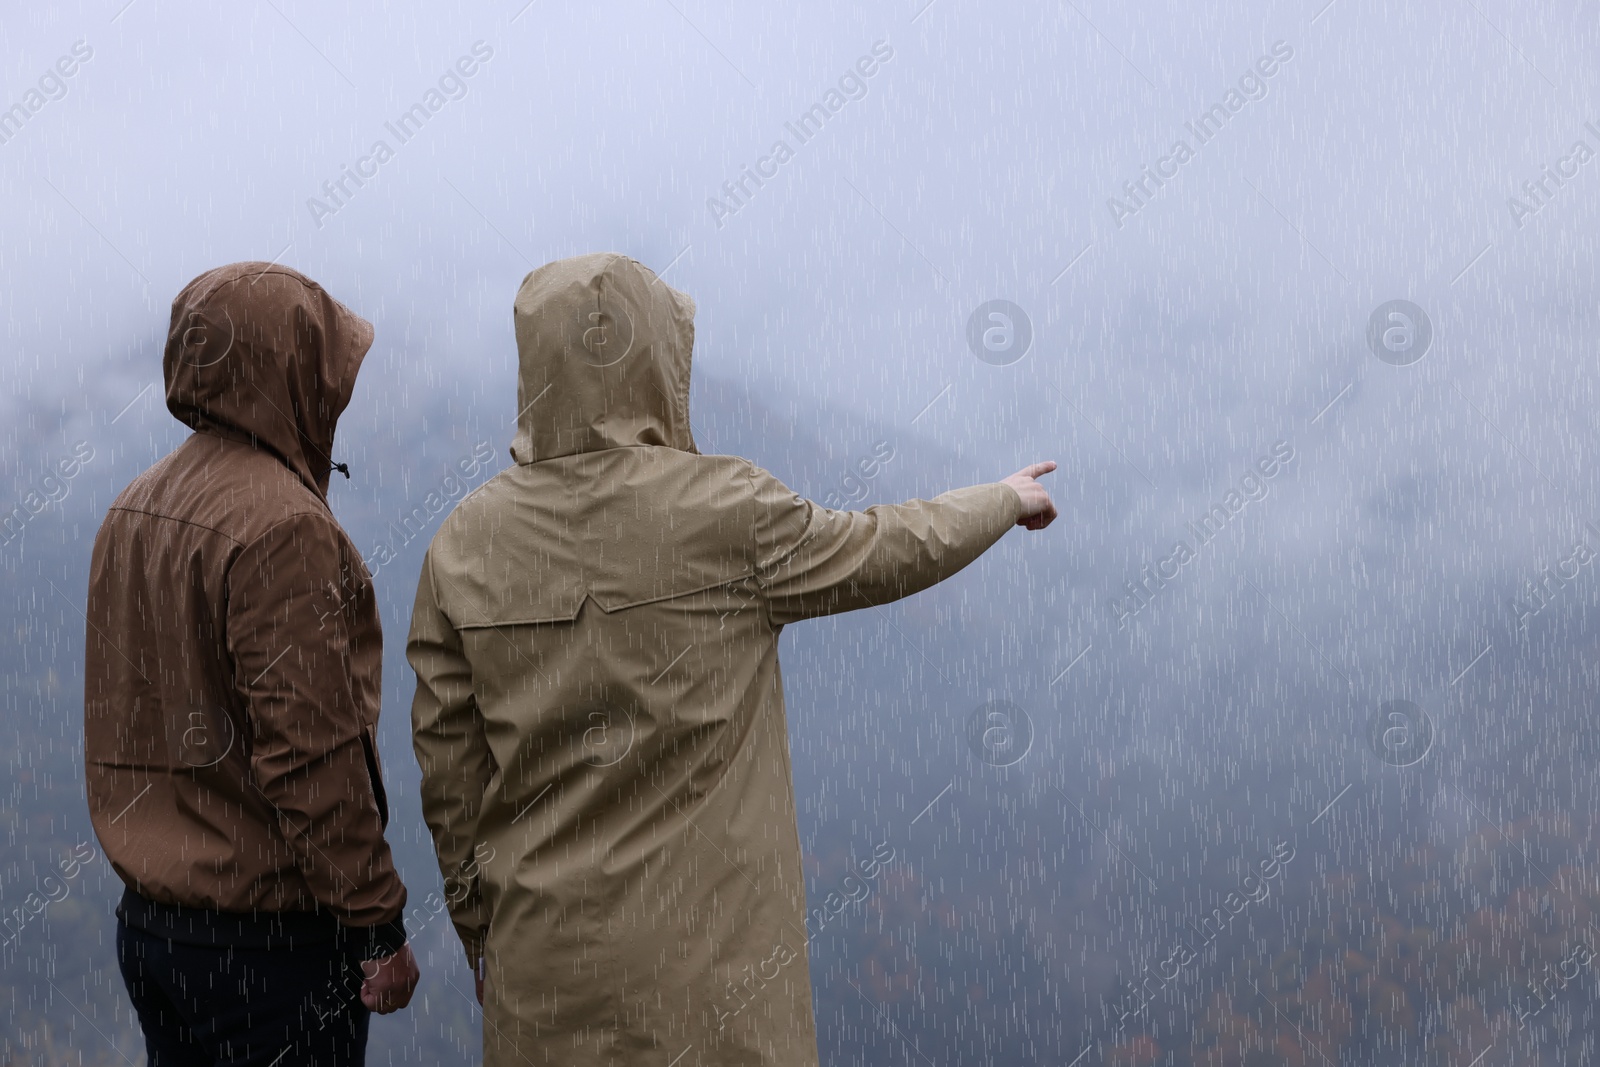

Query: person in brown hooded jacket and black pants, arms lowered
<box><xmin>83</xmin><ymin>262</ymin><xmax>418</xmax><ymax>1067</ymax></box>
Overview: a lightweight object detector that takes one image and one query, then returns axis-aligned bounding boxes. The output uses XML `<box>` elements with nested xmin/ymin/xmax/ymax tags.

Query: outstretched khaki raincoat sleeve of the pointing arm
<box><xmin>750</xmin><ymin>467</ymin><xmax>1022</xmax><ymax>625</ymax></box>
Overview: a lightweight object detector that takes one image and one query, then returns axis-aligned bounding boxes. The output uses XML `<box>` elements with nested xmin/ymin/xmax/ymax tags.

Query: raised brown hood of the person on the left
<box><xmin>162</xmin><ymin>262</ymin><xmax>373</xmax><ymax>498</ymax></box>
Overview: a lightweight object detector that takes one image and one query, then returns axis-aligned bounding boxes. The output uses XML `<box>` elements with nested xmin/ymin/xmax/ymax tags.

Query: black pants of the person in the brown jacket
<box><xmin>117</xmin><ymin>920</ymin><xmax>371</xmax><ymax>1067</ymax></box>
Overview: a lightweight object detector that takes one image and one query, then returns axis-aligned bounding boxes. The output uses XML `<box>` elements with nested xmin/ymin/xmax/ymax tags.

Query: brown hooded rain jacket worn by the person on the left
<box><xmin>83</xmin><ymin>262</ymin><xmax>405</xmax><ymax>950</ymax></box>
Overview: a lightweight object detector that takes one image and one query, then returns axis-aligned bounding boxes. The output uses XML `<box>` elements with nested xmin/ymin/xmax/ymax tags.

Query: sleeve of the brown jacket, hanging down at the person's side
<box><xmin>227</xmin><ymin>515</ymin><xmax>405</xmax><ymax>957</ymax></box>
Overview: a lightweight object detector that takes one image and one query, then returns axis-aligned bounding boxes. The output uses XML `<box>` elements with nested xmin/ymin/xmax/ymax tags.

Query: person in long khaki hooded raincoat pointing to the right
<box><xmin>406</xmin><ymin>254</ymin><xmax>1056</xmax><ymax>1067</ymax></box>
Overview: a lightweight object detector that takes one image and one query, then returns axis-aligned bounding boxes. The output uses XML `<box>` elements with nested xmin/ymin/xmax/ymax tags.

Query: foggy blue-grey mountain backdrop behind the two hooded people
<box><xmin>0</xmin><ymin>0</ymin><xmax>1600</xmax><ymax>1067</ymax></box>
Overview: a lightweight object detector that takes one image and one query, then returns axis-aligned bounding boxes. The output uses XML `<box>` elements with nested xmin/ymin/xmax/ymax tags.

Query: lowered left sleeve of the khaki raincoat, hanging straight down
<box><xmin>406</xmin><ymin>552</ymin><xmax>494</xmax><ymax>966</ymax></box>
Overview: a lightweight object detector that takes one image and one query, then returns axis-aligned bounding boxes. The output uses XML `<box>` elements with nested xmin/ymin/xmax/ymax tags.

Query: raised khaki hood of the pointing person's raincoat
<box><xmin>510</xmin><ymin>253</ymin><xmax>696</xmax><ymax>464</ymax></box>
